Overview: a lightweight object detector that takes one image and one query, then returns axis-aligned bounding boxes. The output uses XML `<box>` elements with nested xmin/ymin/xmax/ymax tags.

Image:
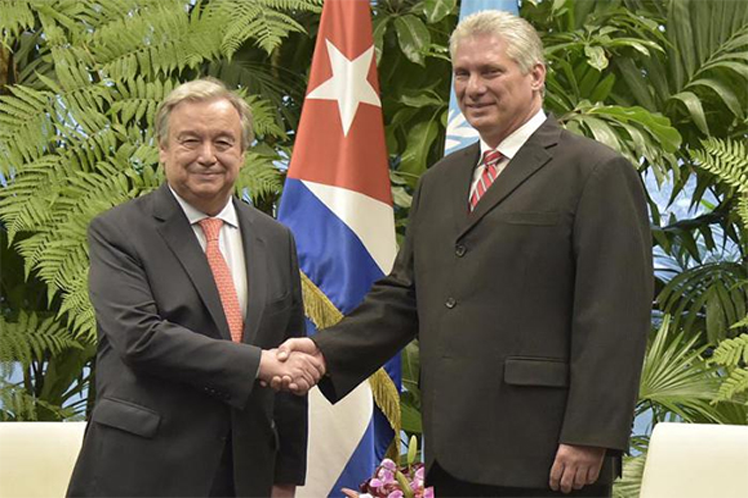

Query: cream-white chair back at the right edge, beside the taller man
<box><xmin>640</xmin><ymin>423</ymin><xmax>748</xmax><ymax>498</ymax></box>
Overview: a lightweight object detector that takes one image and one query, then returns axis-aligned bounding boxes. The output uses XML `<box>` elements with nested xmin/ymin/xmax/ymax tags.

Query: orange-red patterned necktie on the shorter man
<box><xmin>198</xmin><ymin>218</ymin><xmax>244</xmax><ymax>342</ymax></box>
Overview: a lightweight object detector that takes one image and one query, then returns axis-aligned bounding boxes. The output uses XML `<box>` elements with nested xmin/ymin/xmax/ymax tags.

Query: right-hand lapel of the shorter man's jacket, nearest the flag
<box><xmin>234</xmin><ymin>199</ymin><xmax>270</xmax><ymax>344</ymax></box>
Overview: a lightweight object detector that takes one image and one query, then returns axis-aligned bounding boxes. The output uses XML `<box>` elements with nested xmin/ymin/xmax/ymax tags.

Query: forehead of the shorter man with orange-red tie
<box><xmin>169</xmin><ymin>98</ymin><xmax>241</xmax><ymax>134</ymax></box>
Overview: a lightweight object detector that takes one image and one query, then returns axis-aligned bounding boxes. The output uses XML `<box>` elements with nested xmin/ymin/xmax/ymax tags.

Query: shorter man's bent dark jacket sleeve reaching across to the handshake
<box><xmin>88</xmin><ymin>217</ymin><xmax>261</xmax><ymax>409</ymax></box>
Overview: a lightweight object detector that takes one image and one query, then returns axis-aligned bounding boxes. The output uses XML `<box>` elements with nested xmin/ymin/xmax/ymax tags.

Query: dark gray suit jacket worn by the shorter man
<box><xmin>68</xmin><ymin>185</ymin><xmax>307</xmax><ymax>497</ymax></box>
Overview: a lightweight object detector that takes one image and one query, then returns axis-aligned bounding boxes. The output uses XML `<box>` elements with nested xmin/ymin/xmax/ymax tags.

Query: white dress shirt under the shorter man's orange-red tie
<box><xmin>169</xmin><ymin>185</ymin><xmax>247</xmax><ymax>321</ymax></box>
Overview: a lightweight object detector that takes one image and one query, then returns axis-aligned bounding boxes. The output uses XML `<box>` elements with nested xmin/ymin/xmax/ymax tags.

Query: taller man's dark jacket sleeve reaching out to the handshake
<box><xmin>312</xmin><ymin>184</ymin><xmax>422</xmax><ymax>403</ymax></box>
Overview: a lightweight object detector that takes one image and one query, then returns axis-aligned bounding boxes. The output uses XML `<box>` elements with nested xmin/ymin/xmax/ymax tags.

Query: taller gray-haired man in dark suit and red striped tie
<box><xmin>273</xmin><ymin>11</ymin><xmax>653</xmax><ymax>497</ymax></box>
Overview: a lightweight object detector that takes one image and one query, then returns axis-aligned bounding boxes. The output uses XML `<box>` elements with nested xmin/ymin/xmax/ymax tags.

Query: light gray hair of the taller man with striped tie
<box><xmin>449</xmin><ymin>10</ymin><xmax>545</xmax><ymax>74</ymax></box>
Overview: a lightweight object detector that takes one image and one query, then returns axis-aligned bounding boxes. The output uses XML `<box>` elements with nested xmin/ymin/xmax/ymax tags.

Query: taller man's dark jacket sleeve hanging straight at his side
<box><xmin>560</xmin><ymin>156</ymin><xmax>654</xmax><ymax>451</ymax></box>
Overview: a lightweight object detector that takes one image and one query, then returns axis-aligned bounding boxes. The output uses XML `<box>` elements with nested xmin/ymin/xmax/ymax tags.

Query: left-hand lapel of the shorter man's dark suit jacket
<box><xmin>153</xmin><ymin>183</ymin><xmax>231</xmax><ymax>340</ymax></box>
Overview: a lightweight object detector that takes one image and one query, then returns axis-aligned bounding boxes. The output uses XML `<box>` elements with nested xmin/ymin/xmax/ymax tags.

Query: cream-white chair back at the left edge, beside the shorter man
<box><xmin>0</xmin><ymin>422</ymin><xmax>86</xmax><ymax>498</ymax></box>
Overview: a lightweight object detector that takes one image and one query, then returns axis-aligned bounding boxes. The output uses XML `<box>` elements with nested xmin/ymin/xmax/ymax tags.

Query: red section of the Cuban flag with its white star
<box><xmin>288</xmin><ymin>0</ymin><xmax>392</xmax><ymax>205</ymax></box>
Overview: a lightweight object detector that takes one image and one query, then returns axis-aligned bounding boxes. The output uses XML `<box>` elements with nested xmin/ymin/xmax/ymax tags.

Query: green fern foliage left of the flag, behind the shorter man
<box><xmin>0</xmin><ymin>0</ymin><xmax>321</xmax><ymax>420</ymax></box>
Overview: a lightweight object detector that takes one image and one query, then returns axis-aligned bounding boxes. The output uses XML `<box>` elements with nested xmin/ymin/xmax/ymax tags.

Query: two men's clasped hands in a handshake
<box><xmin>258</xmin><ymin>337</ymin><xmax>327</xmax><ymax>396</ymax></box>
